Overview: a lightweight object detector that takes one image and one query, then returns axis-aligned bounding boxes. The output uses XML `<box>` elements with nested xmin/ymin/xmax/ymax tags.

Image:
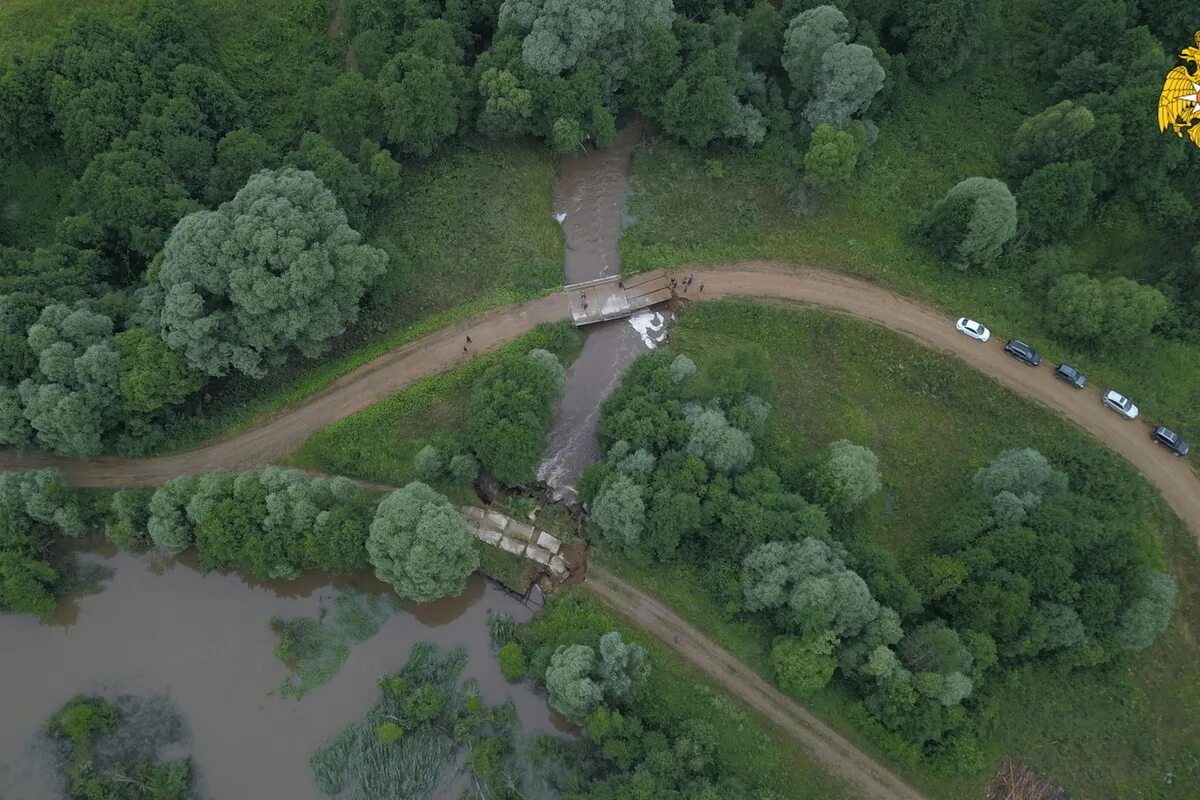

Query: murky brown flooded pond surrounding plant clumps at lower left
<box><xmin>0</xmin><ymin>552</ymin><xmax>563</xmax><ymax>800</ymax></box>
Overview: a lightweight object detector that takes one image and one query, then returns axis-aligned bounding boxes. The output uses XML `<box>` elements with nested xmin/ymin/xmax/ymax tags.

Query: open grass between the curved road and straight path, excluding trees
<box><xmin>602</xmin><ymin>302</ymin><xmax>1200</xmax><ymax>798</ymax></box>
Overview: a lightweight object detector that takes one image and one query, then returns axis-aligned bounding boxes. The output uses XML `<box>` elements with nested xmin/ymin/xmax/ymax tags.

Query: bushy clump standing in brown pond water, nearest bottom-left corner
<box><xmin>46</xmin><ymin>694</ymin><xmax>192</xmax><ymax>800</ymax></box>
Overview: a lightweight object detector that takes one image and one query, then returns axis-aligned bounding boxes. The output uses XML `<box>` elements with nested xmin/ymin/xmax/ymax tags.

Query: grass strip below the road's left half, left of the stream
<box><xmin>282</xmin><ymin>323</ymin><xmax>583</xmax><ymax>486</ymax></box>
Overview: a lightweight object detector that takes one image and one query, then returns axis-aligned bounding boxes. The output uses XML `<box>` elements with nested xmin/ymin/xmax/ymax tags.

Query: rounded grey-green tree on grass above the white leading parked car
<box><xmin>917</xmin><ymin>178</ymin><xmax>1016</xmax><ymax>270</ymax></box>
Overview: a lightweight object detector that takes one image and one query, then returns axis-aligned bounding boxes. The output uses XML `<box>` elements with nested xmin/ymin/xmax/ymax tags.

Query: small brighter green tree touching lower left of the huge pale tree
<box><xmin>113</xmin><ymin>327</ymin><xmax>204</xmax><ymax>411</ymax></box>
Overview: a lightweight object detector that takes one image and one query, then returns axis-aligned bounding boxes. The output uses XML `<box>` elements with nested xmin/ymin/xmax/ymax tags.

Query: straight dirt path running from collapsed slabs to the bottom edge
<box><xmin>583</xmin><ymin>563</ymin><xmax>923</xmax><ymax>800</ymax></box>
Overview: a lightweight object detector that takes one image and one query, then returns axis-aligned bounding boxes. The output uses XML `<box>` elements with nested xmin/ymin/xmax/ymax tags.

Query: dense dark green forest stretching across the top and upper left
<box><xmin>0</xmin><ymin>0</ymin><xmax>1200</xmax><ymax>456</ymax></box>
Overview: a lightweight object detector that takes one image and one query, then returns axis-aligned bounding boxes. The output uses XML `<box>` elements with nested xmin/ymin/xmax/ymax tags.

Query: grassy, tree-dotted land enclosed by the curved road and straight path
<box><xmin>600</xmin><ymin>303</ymin><xmax>1200</xmax><ymax>796</ymax></box>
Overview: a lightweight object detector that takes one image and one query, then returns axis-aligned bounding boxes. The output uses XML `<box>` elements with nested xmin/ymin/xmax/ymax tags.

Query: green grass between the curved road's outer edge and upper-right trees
<box><xmin>622</xmin><ymin>71</ymin><xmax>1200</xmax><ymax>448</ymax></box>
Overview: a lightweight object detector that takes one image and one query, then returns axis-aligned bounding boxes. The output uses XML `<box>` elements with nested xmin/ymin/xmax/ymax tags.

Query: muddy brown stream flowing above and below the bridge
<box><xmin>538</xmin><ymin>122</ymin><xmax>666</xmax><ymax>489</ymax></box>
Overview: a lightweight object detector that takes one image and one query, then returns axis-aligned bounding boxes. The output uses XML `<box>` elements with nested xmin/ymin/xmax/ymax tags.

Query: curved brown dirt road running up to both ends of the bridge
<box><xmin>0</xmin><ymin>261</ymin><xmax>1200</xmax><ymax>535</ymax></box>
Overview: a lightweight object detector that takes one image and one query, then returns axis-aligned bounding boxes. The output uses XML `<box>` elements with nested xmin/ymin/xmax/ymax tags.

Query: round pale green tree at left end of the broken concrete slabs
<box><xmin>367</xmin><ymin>482</ymin><xmax>479</xmax><ymax>602</ymax></box>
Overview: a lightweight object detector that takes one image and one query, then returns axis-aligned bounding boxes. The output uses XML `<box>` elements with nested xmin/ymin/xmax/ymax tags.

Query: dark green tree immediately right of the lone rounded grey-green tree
<box><xmin>1016</xmin><ymin>161</ymin><xmax>1096</xmax><ymax>243</ymax></box>
